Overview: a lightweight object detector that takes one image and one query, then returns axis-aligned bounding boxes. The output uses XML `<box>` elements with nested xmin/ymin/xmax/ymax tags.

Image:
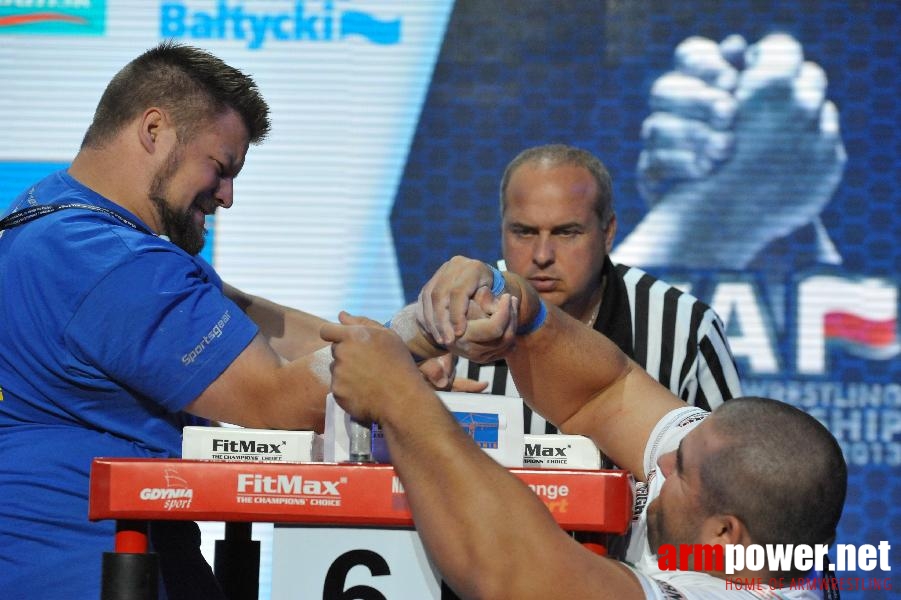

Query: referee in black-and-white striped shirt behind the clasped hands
<box><xmin>454</xmin><ymin>144</ymin><xmax>741</xmax><ymax>433</ymax></box>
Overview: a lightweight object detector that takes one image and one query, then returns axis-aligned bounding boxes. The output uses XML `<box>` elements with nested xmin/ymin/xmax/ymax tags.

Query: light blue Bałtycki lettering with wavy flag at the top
<box><xmin>160</xmin><ymin>0</ymin><xmax>401</xmax><ymax>50</ymax></box>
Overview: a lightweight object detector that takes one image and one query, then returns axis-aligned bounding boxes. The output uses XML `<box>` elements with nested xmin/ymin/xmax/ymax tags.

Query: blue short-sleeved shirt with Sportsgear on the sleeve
<box><xmin>0</xmin><ymin>171</ymin><xmax>257</xmax><ymax>600</ymax></box>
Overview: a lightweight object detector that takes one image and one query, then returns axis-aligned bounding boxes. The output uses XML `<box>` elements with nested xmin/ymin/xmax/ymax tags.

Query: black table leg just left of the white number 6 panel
<box><xmin>213</xmin><ymin>523</ymin><xmax>260</xmax><ymax>600</ymax></box>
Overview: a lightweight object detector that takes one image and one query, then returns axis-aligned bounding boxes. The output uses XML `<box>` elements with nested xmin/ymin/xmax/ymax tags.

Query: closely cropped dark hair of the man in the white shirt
<box><xmin>701</xmin><ymin>397</ymin><xmax>848</xmax><ymax>576</ymax></box>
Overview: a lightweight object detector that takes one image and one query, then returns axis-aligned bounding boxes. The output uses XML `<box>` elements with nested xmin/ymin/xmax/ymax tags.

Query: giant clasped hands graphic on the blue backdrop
<box><xmin>613</xmin><ymin>34</ymin><xmax>846</xmax><ymax>269</ymax></box>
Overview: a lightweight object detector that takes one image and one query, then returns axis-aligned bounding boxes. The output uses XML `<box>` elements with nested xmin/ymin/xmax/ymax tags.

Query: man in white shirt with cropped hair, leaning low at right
<box><xmin>320</xmin><ymin>257</ymin><xmax>847</xmax><ymax>600</ymax></box>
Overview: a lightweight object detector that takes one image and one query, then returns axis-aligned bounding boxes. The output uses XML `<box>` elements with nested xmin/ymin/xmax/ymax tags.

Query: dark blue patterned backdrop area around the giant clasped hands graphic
<box><xmin>391</xmin><ymin>0</ymin><xmax>901</xmax><ymax>598</ymax></box>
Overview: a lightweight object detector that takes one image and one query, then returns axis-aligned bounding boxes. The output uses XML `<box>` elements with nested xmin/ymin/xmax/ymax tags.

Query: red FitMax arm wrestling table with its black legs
<box><xmin>88</xmin><ymin>458</ymin><xmax>633</xmax><ymax>600</ymax></box>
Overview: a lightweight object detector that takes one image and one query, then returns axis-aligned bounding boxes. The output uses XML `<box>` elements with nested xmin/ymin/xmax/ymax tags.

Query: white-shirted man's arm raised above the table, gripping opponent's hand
<box><xmin>420</xmin><ymin>257</ymin><xmax>684</xmax><ymax>479</ymax></box>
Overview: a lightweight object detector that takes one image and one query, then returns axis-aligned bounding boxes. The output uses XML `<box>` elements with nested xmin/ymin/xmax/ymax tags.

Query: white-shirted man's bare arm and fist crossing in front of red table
<box><xmin>322</xmin><ymin>317</ymin><xmax>643</xmax><ymax>600</ymax></box>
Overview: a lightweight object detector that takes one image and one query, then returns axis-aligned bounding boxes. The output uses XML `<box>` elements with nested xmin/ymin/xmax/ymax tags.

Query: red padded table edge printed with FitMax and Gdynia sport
<box><xmin>88</xmin><ymin>458</ymin><xmax>633</xmax><ymax>534</ymax></box>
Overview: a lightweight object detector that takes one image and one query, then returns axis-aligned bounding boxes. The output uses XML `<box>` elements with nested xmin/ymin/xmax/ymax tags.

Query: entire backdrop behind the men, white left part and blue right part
<box><xmin>0</xmin><ymin>0</ymin><xmax>901</xmax><ymax>599</ymax></box>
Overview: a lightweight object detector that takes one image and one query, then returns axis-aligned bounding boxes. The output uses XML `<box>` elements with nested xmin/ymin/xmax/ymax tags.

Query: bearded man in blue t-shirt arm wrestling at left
<box><xmin>0</xmin><ymin>42</ymin><xmax>458</xmax><ymax>600</ymax></box>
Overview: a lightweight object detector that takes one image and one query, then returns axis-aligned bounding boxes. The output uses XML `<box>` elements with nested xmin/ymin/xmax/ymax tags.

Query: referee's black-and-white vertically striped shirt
<box><xmin>456</xmin><ymin>258</ymin><xmax>741</xmax><ymax>433</ymax></box>
